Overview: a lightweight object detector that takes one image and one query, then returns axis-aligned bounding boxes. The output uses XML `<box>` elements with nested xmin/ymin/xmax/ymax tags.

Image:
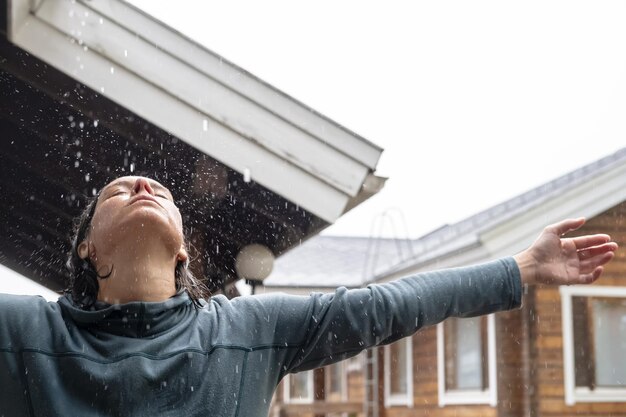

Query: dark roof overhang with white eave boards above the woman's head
<box><xmin>0</xmin><ymin>0</ymin><xmax>384</xmax><ymax>290</ymax></box>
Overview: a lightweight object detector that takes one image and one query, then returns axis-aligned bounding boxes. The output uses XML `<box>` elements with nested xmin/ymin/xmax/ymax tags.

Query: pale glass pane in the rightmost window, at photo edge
<box><xmin>593</xmin><ymin>298</ymin><xmax>626</xmax><ymax>387</ymax></box>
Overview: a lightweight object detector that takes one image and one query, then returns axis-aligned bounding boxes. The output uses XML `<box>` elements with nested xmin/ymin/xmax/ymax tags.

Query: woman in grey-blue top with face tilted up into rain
<box><xmin>0</xmin><ymin>177</ymin><xmax>617</xmax><ymax>416</ymax></box>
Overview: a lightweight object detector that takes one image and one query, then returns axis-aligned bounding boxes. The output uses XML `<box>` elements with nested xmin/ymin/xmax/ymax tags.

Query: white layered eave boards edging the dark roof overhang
<box><xmin>7</xmin><ymin>0</ymin><xmax>383</xmax><ymax>223</ymax></box>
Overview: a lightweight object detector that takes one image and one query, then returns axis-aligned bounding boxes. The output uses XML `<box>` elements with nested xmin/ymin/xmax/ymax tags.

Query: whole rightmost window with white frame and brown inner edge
<box><xmin>560</xmin><ymin>285</ymin><xmax>626</xmax><ymax>405</ymax></box>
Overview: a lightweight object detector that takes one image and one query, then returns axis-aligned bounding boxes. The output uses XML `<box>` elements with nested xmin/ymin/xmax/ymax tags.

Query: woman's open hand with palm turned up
<box><xmin>514</xmin><ymin>218</ymin><xmax>617</xmax><ymax>285</ymax></box>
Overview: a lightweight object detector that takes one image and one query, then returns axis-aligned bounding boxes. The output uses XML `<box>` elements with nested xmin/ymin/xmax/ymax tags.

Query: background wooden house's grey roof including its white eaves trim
<box><xmin>265</xmin><ymin>148</ymin><xmax>626</xmax><ymax>288</ymax></box>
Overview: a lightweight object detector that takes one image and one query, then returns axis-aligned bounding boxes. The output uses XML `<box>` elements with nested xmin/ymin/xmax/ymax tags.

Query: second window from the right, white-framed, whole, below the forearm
<box><xmin>437</xmin><ymin>315</ymin><xmax>497</xmax><ymax>407</ymax></box>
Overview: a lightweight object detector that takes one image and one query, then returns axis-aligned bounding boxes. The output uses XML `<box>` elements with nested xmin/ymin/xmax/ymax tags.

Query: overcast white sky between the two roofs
<box><xmin>132</xmin><ymin>0</ymin><xmax>626</xmax><ymax>237</ymax></box>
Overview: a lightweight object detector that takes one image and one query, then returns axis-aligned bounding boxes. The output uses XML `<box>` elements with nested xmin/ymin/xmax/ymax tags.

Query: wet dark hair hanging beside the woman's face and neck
<box><xmin>65</xmin><ymin>180</ymin><xmax>210</xmax><ymax>309</ymax></box>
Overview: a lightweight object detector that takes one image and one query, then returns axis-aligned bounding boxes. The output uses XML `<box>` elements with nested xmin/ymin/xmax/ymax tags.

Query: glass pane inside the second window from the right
<box><xmin>444</xmin><ymin>317</ymin><xmax>487</xmax><ymax>390</ymax></box>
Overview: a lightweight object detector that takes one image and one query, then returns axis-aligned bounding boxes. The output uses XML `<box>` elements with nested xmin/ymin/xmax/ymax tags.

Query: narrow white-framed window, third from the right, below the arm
<box><xmin>385</xmin><ymin>337</ymin><xmax>413</xmax><ymax>407</ymax></box>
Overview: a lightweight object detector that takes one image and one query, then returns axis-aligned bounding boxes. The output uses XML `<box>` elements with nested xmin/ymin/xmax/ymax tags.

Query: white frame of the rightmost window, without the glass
<box><xmin>559</xmin><ymin>285</ymin><xmax>626</xmax><ymax>405</ymax></box>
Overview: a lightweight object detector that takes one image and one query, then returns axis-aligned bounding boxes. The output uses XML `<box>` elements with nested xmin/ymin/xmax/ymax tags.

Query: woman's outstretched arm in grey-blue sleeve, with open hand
<box><xmin>222</xmin><ymin>219</ymin><xmax>617</xmax><ymax>375</ymax></box>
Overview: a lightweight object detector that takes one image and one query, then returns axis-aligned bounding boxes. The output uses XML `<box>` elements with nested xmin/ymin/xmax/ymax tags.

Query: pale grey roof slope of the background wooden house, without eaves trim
<box><xmin>265</xmin><ymin>148</ymin><xmax>626</xmax><ymax>287</ymax></box>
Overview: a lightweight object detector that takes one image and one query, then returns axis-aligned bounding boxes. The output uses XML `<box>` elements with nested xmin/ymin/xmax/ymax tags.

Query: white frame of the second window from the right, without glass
<box><xmin>437</xmin><ymin>314</ymin><xmax>498</xmax><ymax>407</ymax></box>
